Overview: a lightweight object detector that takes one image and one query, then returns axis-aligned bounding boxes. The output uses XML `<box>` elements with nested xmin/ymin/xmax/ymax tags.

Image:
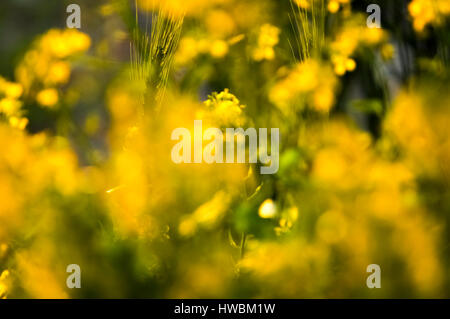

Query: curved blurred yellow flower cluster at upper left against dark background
<box><xmin>16</xmin><ymin>29</ymin><xmax>91</xmax><ymax>107</ymax></box>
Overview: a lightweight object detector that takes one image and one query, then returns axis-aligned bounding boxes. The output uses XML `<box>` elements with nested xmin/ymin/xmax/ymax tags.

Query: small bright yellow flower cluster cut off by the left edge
<box><xmin>0</xmin><ymin>76</ymin><xmax>28</xmax><ymax>130</ymax></box>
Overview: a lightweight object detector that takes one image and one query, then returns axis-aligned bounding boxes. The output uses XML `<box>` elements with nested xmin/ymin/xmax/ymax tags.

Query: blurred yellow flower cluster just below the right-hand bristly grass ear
<box><xmin>269</xmin><ymin>59</ymin><xmax>338</xmax><ymax>114</ymax></box>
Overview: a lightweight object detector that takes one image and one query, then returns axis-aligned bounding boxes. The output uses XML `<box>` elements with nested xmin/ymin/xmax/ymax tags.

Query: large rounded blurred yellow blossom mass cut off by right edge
<box><xmin>384</xmin><ymin>84</ymin><xmax>450</xmax><ymax>176</ymax></box>
